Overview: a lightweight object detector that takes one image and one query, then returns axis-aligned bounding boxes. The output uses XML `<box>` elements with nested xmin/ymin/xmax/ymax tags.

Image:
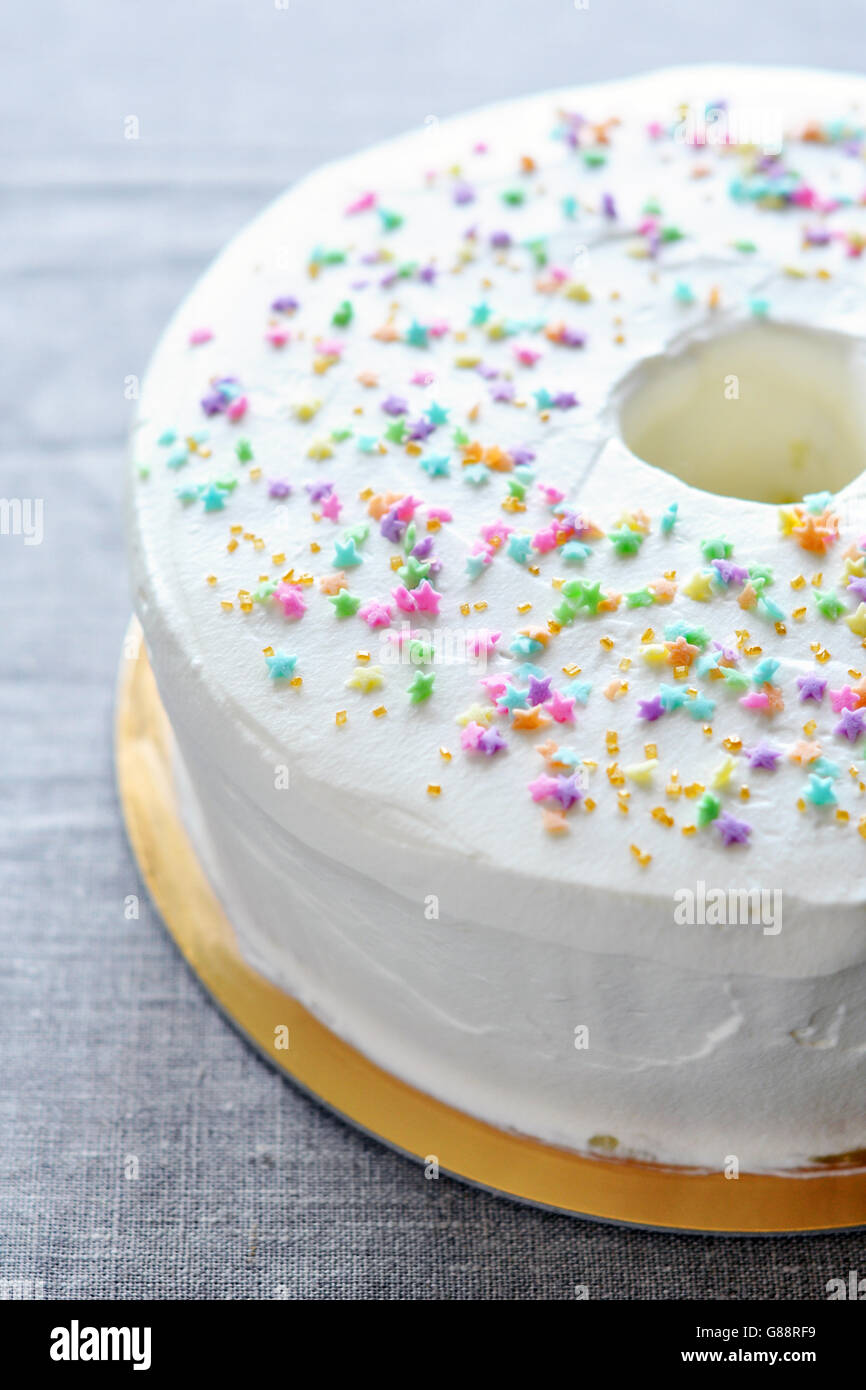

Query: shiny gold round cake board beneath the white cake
<box><xmin>115</xmin><ymin>620</ymin><xmax>866</xmax><ymax>1234</ymax></box>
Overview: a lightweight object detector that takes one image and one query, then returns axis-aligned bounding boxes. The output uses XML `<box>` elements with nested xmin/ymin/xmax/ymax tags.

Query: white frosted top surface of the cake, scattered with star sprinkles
<box><xmin>131</xmin><ymin>68</ymin><xmax>866</xmax><ymax>934</ymax></box>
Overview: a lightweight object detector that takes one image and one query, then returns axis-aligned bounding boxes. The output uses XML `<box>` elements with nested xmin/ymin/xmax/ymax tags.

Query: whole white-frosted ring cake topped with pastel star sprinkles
<box><xmin>129</xmin><ymin>67</ymin><xmax>866</xmax><ymax>1170</ymax></box>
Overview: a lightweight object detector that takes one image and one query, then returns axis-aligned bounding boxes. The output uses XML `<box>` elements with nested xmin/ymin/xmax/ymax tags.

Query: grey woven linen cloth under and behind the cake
<box><xmin>0</xmin><ymin>0</ymin><xmax>866</xmax><ymax>1300</ymax></box>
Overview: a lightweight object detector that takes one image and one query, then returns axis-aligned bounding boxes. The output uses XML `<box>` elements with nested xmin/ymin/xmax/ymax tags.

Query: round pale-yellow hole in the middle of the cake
<box><xmin>619</xmin><ymin>324</ymin><xmax>866</xmax><ymax>505</ymax></box>
